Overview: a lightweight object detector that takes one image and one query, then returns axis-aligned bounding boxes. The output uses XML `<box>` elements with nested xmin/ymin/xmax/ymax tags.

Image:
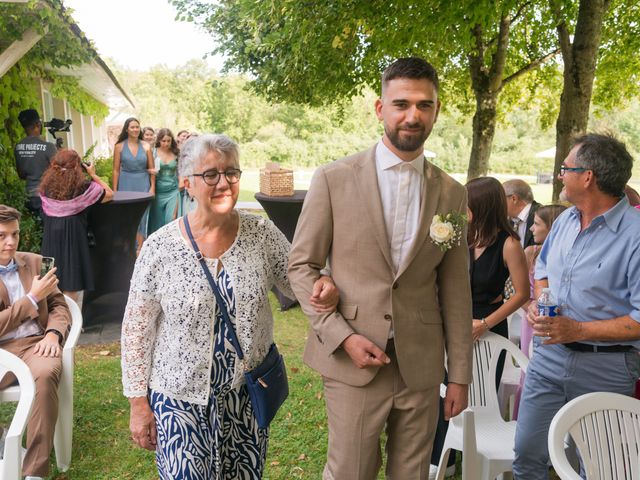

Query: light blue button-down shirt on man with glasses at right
<box><xmin>535</xmin><ymin>196</ymin><xmax>640</xmax><ymax>348</ymax></box>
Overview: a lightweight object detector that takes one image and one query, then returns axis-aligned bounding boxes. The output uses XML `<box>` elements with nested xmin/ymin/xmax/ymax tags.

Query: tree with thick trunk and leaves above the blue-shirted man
<box><xmin>549</xmin><ymin>0</ymin><xmax>640</xmax><ymax>198</ymax></box>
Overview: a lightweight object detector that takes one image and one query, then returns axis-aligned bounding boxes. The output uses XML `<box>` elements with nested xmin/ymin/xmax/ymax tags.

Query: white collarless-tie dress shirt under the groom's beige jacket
<box><xmin>376</xmin><ymin>141</ymin><xmax>424</xmax><ymax>272</ymax></box>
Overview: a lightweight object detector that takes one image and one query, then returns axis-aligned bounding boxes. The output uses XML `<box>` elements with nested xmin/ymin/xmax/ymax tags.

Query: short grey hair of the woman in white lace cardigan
<box><xmin>178</xmin><ymin>133</ymin><xmax>240</xmax><ymax>177</ymax></box>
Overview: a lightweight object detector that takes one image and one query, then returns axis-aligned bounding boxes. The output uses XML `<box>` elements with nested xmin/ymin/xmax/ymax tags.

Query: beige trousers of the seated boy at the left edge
<box><xmin>0</xmin><ymin>335</ymin><xmax>62</xmax><ymax>477</ymax></box>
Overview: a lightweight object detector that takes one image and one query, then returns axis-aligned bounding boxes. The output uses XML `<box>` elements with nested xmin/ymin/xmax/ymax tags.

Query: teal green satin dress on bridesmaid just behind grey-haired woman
<box><xmin>148</xmin><ymin>158</ymin><xmax>182</xmax><ymax>235</ymax></box>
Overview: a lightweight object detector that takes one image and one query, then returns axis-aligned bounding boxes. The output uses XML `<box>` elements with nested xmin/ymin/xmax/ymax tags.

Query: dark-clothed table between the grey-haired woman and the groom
<box><xmin>255</xmin><ymin>190</ymin><xmax>307</xmax><ymax>310</ymax></box>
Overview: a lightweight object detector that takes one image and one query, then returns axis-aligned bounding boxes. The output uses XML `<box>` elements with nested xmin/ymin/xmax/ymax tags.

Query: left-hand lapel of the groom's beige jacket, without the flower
<box><xmin>354</xmin><ymin>147</ymin><xmax>393</xmax><ymax>270</ymax></box>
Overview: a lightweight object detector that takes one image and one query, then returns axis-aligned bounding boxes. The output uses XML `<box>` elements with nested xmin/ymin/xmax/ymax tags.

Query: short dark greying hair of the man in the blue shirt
<box><xmin>571</xmin><ymin>133</ymin><xmax>633</xmax><ymax>197</ymax></box>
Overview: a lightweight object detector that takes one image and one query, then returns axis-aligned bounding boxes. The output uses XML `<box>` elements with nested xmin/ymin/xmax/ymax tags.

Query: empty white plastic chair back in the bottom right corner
<box><xmin>548</xmin><ymin>392</ymin><xmax>640</xmax><ymax>480</ymax></box>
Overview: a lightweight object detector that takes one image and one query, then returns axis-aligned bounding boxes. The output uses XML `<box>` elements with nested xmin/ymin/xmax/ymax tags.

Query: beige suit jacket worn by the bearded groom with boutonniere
<box><xmin>289</xmin><ymin>147</ymin><xmax>472</xmax><ymax>391</ymax></box>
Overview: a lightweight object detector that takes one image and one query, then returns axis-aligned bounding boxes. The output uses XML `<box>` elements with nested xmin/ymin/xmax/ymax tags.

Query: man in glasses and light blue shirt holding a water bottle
<box><xmin>513</xmin><ymin>134</ymin><xmax>640</xmax><ymax>480</ymax></box>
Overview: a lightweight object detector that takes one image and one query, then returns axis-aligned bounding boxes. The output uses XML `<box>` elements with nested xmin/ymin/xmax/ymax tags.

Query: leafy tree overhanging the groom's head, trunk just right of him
<box><xmin>173</xmin><ymin>0</ymin><xmax>557</xmax><ymax>176</ymax></box>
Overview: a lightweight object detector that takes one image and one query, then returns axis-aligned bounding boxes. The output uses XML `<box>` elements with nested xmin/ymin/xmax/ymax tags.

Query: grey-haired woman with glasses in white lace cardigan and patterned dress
<box><xmin>122</xmin><ymin>134</ymin><xmax>338</xmax><ymax>480</ymax></box>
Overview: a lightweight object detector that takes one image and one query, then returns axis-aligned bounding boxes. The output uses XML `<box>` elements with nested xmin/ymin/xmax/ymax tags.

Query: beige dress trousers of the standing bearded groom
<box><xmin>323</xmin><ymin>344</ymin><xmax>440</xmax><ymax>480</ymax></box>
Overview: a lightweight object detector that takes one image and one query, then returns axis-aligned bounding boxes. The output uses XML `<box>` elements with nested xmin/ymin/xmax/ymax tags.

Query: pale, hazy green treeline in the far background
<box><xmin>116</xmin><ymin>62</ymin><xmax>640</xmax><ymax>180</ymax></box>
